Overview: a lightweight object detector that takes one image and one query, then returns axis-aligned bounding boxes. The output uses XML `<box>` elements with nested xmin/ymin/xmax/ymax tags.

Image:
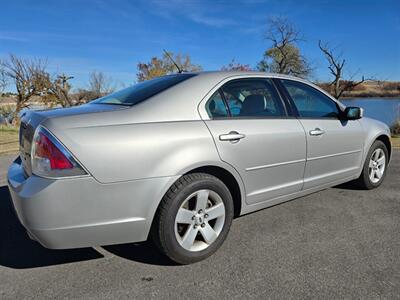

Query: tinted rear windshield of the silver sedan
<box><xmin>91</xmin><ymin>74</ymin><xmax>196</xmax><ymax>105</ymax></box>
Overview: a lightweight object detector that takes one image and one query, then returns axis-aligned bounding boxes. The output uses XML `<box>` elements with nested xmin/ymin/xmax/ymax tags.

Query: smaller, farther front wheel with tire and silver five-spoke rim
<box><xmin>356</xmin><ymin>140</ymin><xmax>389</xmax><ymax>190</ymax></box>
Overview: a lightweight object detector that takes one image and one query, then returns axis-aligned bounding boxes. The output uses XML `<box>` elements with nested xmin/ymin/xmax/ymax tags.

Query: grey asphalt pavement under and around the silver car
<box><xmin>0</xmin><ymin>151</ymin><xmax>400</xmax><ymax>299</ymax></box>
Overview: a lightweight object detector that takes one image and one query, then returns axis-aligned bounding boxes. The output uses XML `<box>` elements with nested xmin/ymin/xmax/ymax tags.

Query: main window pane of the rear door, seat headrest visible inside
<box><xmin>222</xmin><ymin>79</ymin><xmax>285</xmax><ymax>117</ymax></box>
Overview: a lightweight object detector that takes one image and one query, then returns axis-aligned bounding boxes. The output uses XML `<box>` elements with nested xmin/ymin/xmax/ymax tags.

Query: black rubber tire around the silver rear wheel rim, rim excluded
<box><xmin>160</xmin><ymin>177</ymin><xmax>233</xmax><ymax>264</ymax></box>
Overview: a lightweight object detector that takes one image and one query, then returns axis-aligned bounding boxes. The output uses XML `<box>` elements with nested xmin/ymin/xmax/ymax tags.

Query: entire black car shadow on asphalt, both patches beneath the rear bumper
<box><xmin>0</xmin><ymin>186</ymin><xmax>177</xmax><ymax>269</ymax></box>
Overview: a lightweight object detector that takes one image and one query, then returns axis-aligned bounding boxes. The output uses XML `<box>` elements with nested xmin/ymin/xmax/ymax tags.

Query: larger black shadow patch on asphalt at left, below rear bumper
<box><xmin>0</xmin><ymin>186</ymin><xmax>103</xmax><ymax>269</ymax></box>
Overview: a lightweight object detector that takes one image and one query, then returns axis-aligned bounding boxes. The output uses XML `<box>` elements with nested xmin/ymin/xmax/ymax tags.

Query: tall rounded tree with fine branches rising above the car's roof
<box><xmin>258</xmin><ymin>17</ymin><xmax>312</xmax><ymax>77</ymax></box>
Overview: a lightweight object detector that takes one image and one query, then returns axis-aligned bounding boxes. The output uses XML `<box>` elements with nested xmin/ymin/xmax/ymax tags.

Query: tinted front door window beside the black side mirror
<box><xmin>281</xmin><ymin>79</ymin><xmax>339</xmax><ymax>118</ymax></box>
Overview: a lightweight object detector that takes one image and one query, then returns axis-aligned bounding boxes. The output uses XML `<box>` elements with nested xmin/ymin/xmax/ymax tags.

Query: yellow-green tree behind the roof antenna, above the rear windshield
<box><xmin>136</xmin><ymin>52</ymin><xmax>202</xmax><ymax>81</ymax></box>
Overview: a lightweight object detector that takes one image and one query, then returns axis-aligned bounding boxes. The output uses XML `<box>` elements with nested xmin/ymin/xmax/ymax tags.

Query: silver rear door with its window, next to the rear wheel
<box><xmin>205</xmin><ymin>78</ymin><xmax>306</xmax><ymax>204</ymax></box>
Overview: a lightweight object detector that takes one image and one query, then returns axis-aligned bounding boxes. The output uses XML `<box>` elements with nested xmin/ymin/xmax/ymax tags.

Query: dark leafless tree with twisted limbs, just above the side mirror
<box><xmin>318</xmin><ymin>41</ymin><xmax>366</xmax><ymax>99</ymax></box>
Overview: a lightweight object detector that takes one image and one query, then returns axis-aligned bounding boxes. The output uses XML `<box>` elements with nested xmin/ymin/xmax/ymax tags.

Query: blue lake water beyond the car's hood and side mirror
<box><xmin>341</xmin><ymin>98</ymin><xmax>400</xmax><ymax>126</ymax></box>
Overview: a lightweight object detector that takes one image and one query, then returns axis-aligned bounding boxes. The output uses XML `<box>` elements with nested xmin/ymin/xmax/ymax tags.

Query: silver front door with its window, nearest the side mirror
<box><xmin>280</xmin><ymin>79</ymin><xmax>363</xmax><ymax>189</ymax></box>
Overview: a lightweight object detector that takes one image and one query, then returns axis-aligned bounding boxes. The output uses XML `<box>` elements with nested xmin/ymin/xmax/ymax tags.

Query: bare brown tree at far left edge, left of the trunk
<box><xmin>1</xmin><ymin>54</ymin><xmax>48</xmax><ymax>120</ymax></box>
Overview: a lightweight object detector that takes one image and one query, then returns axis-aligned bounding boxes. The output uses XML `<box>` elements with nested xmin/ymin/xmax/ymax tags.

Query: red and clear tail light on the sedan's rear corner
<box><xmin>31</xmin><ymin>126</ymin><xmax>86</xmax><ymax>177</ymax></box>
